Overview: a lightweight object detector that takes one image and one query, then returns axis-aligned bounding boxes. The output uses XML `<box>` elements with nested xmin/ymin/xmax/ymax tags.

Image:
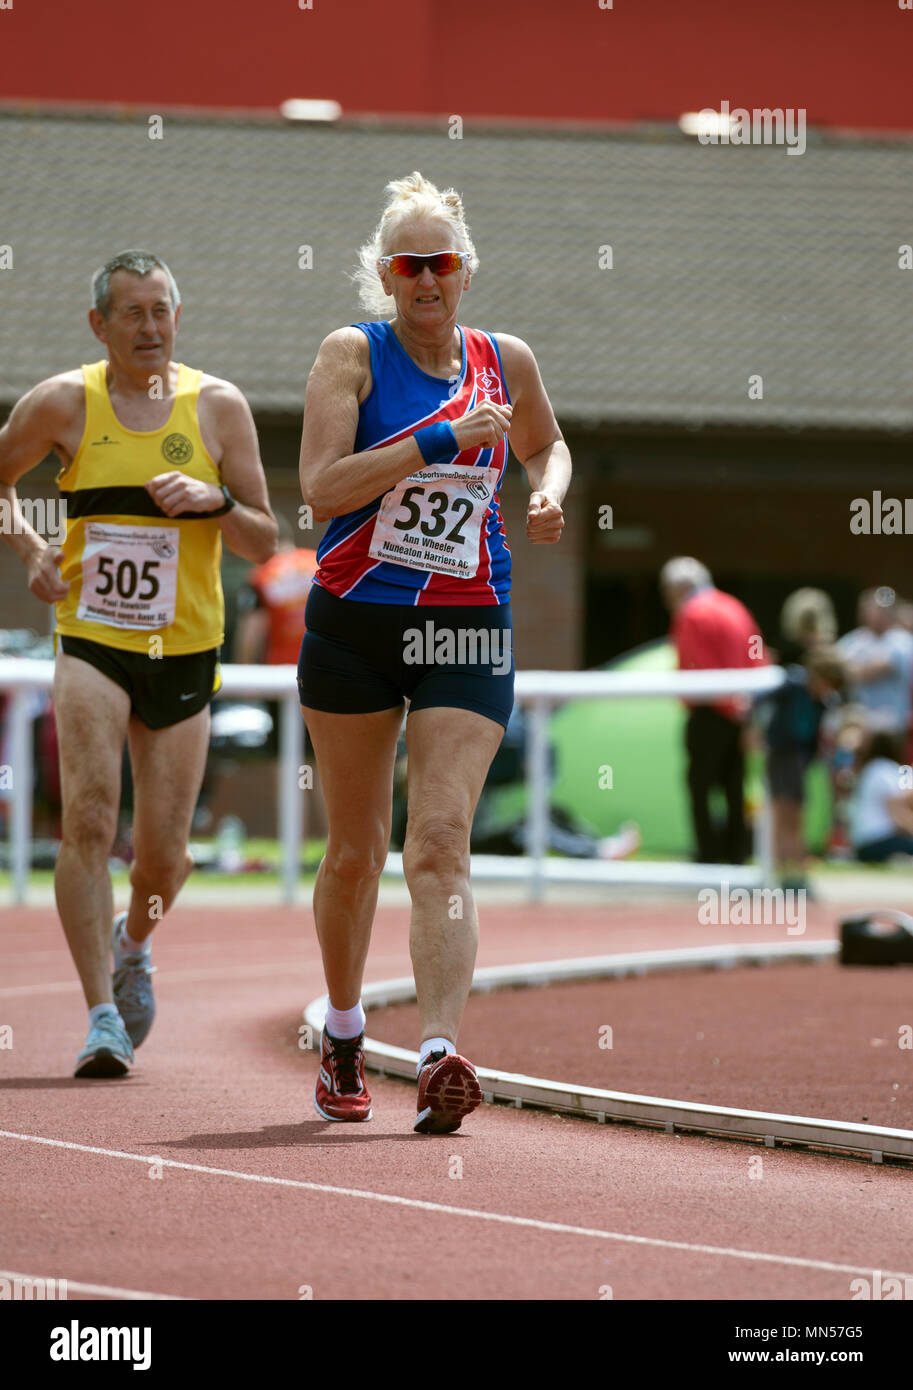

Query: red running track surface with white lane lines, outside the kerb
<box><xmin>0</xmin><ymin>904</ymin><xmax>913</xmax><ymax>1300</ymax></box>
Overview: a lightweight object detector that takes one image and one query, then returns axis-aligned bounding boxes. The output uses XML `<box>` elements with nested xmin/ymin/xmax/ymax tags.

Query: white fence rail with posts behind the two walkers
<box><xmin>0</xmin><ymin>657</ymin><xmax>784</xmax><ymax>904</ymax></box>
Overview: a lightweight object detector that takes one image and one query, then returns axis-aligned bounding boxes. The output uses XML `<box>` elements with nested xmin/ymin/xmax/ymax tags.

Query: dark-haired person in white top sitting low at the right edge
<box><xmin>849</xmin><ymin>730</ymin><xmax>913</xmax><ymax>863</ymax></box>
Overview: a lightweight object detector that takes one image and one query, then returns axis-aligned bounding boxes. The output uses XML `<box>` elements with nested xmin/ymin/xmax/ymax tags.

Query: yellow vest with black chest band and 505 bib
<box><xmin>57</xmin><ymin>361</ymin><xmax>225</xmax><ymax>656</ymax></box>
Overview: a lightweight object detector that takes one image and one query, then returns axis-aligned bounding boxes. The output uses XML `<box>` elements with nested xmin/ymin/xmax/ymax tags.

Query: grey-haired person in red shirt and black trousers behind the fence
<box><xmin>660</xmin><ymin>556</ymin><xmax>766</xmax><ymax>865</ymax></box>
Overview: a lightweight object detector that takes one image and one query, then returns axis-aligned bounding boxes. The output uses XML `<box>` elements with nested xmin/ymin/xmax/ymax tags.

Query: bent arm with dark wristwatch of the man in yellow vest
<box><xmin>146</xmin><ymin>382</ymin><xmax>278</xmax><ymax>564</ymax></box>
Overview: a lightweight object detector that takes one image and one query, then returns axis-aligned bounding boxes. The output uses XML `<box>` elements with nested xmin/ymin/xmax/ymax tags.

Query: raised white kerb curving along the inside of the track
<box><xmin>304</xmin><ymin>941</ymin><xmax>913</xmax><ymax>1163</ymax></box>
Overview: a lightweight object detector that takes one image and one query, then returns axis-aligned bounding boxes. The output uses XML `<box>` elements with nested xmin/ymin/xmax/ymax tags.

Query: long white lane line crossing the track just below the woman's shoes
<box><xmin>0</xmin><ymin>1130</ymin><xmax>913</xmax><ymax>1279</ymax></box>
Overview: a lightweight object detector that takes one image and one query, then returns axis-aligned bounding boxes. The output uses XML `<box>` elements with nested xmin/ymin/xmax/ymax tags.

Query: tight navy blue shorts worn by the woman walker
<box><xmin>297</xmin><ymin>584</ymin><xmax>514</xmax><ymax>728</ymax></box>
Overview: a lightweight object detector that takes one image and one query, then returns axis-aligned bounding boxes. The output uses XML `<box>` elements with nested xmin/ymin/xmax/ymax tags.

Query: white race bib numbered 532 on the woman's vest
<box><xmin>368</xmin><ymin>463</ymin><xmax>499</xmax><ymax>580</ymax></box>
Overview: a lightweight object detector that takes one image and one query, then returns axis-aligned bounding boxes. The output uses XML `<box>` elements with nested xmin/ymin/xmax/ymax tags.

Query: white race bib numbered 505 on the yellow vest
<box><xmin>76</xmin><ymin>521</ymin><xmax>181</xmax><ymax>630</ymax></box>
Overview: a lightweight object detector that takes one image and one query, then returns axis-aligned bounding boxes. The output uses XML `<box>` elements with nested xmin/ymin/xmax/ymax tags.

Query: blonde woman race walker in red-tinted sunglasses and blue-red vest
<box><xmin>299</xmin><ymin>174</ymin><xmax>571</xmax><ymax>1134</ymax></box>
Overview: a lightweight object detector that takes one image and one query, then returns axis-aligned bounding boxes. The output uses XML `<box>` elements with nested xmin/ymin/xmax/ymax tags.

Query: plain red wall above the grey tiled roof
<box><xmin>0</xmin><ymin>0</ymin><xmax>913</xmax><ymax>131</ymax></box>
